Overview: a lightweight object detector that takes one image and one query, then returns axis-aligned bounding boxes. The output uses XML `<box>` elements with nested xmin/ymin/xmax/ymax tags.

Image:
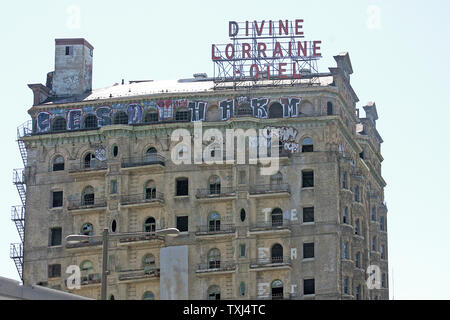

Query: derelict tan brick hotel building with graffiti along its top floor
<box><xmin>11</xmin><ymin>39</ymin><xmax>389</xmax><ymax>299</ymax></box>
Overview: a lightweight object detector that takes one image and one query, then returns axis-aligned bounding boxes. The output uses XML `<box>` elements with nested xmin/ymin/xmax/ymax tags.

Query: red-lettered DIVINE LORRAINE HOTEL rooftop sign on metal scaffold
<box><xmin>211</xmin><ymin>19</ymin><xmax>322</xmax><ymax>82</ymax></box>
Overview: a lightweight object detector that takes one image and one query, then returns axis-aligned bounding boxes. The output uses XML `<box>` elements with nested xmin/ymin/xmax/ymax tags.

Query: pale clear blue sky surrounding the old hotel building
<box><xmin>0</xmin><ymin>0</ymin><xmax>450</xmax><ymax>299</ymax></box>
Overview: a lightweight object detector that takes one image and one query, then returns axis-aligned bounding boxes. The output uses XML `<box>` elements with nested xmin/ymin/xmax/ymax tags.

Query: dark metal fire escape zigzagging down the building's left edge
<box><xmin>10</xmin><ymin>120</ymin><xmax>32</xmax><ymax>281</ymax></box>
